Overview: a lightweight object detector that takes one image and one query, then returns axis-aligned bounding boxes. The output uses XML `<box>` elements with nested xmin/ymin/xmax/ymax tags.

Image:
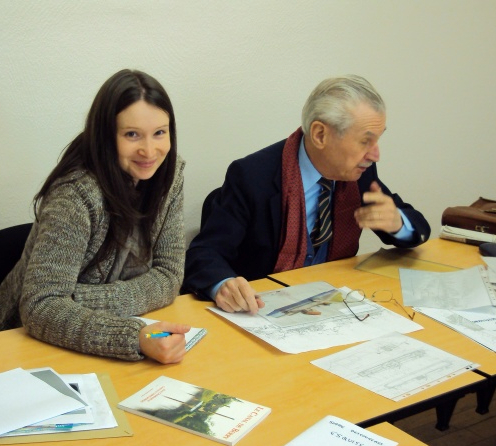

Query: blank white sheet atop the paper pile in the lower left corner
<box><xmin>0</xmin><ymin>368</ymin><xmax>84</xmax><ymax>435</ymax></box>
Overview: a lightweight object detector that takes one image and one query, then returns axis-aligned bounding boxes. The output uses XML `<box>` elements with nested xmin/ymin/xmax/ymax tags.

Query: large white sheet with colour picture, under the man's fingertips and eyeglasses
<box><xmin>208</xmin><ymin>282</ymin><xmax>422</xmax><ymax>353</ymax></box>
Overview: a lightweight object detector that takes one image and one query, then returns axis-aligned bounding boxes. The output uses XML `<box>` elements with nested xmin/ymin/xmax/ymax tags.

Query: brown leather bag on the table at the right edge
<box><xmin>441</xmin><ymin>197</ymin><xmax>496</xmax><ymax>234</ymax></box>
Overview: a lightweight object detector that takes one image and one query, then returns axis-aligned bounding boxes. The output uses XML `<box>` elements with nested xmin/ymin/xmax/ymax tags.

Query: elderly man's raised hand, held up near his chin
<box><xmin>355</xmin><ymin>181</ymin><xmax>403</xmax><ymax>233</ymax></box>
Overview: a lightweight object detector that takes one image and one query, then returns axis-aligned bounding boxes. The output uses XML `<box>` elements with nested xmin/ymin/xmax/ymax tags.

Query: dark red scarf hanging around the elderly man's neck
<box><xmin>274</xmin><ymin>128</ymin><xmax>362</xmax><ymax>273</ymax></box>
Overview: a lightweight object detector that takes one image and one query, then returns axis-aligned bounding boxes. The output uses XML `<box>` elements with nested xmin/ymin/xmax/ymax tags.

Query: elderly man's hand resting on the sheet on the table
<box><xmin>215</xmin><ymin>277</ymin><xmax>265</xmax><ymax>314</ymax></box>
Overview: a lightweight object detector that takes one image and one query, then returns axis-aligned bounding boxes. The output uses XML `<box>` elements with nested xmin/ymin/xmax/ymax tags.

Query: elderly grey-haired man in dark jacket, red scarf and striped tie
<box><xmin>183</xmin><ymin>75</ymin><xmax>430</xmax><ymax>313</ymax></box>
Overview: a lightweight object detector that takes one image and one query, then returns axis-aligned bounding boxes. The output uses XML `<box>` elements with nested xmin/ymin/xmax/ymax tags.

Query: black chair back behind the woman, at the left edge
<box><xmin>0</xmin><ymin>223</ymin><xmax>33</xmax><ymax>283</ymax></box>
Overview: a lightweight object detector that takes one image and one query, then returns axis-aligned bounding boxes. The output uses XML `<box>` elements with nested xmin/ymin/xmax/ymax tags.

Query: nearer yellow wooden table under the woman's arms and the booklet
<box><xmin>0</xmin><ymin>279</ymin><xmax>450</xmax><ymax>446</ymax></box>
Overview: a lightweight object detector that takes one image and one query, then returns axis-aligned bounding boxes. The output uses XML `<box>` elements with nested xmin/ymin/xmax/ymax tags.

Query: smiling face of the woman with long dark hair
<box><xmin>116</xmin><ymin>100</ymin><xmax>171</xmax><ymax>184</ymax></box>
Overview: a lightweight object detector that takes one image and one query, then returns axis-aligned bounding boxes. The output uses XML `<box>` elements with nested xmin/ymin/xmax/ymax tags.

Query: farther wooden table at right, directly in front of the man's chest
<box><xmin>270</xmin><ymin>239</ymin><xmax>496</xmax><ymax>430</ymax></box>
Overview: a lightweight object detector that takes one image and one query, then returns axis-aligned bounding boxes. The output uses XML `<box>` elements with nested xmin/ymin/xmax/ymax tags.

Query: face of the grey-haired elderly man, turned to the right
<box><xmin>312</xmin><ymin>104</ymin><xmax>386</xmax><ymax>181</ymax></box>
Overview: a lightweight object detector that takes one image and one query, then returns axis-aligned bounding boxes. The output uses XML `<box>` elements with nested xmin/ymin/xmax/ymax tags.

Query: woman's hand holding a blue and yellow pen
<box><xmin>139</xmin><ymin>321</ymin><xmax>191</xmax><ymax>364</ymax></box>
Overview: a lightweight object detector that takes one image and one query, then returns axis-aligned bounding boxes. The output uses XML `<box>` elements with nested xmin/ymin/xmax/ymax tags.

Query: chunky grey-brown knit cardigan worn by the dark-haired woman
<box><xmin>0</xmin><ymin>157</ymin><xmax>185</xmax><ymax>360</ymax></box>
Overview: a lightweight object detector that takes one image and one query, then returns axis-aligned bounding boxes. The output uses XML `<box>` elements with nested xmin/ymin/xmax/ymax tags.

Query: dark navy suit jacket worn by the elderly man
<box><xmin>183</xmin><ymin>136</ymin><xmax>430</xmax><ymax>295</ymax></box>
